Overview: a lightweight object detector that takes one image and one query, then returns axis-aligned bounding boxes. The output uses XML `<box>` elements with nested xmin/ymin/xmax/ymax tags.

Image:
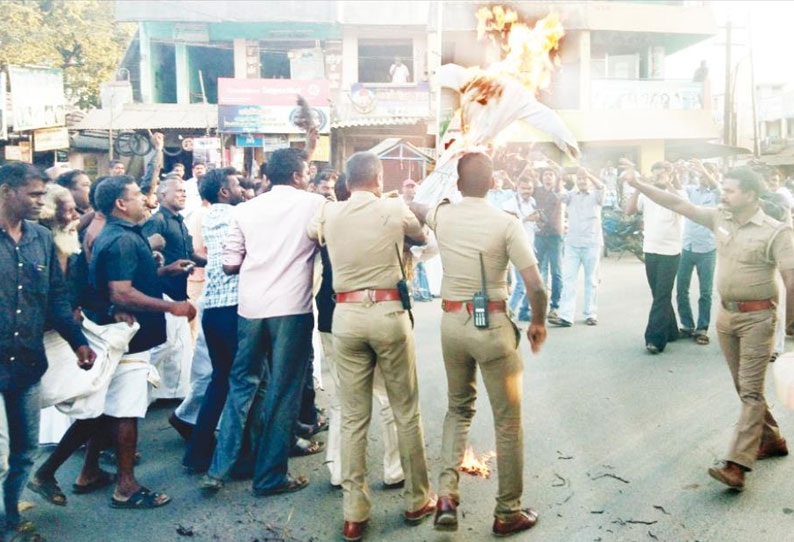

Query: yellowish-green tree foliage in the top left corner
<box><xmin>0</xmin><ymin>0</ymin><xmax>135</xmax><ymax>109</ymax></box>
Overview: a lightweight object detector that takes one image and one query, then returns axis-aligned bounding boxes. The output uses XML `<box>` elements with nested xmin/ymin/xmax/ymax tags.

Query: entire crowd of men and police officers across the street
<box><xmin>0</xmin><ymin>140</ymin><xmax>794</xmax><ymax>541</ymax></box>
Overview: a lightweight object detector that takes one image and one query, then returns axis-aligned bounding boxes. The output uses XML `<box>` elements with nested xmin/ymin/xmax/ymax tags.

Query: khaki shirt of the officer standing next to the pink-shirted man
<box><xmin>308</xmin><ymin>190</ymin><xmax>422</xmax><ymax>293</ymax></box>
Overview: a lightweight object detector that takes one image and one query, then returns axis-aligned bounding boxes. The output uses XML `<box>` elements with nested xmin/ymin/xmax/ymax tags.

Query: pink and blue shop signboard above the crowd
<box><xmin>218</xmin><ymin>78</ymin><xmax>330</xmax><ymax>134</ymax></box>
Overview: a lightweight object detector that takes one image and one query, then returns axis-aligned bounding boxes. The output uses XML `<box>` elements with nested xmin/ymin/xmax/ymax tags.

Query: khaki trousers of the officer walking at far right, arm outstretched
<box><xmin>717</xmin><ymin>307</ymin><xmax>780</xmax><ymax>469</ymax></box>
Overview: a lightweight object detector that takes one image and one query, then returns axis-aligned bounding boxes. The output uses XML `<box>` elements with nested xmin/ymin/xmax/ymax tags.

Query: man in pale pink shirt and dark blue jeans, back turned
<box><xmin>199</xmin><ymin>148</ymin><xmax>325</xmax><ymax>496</ymax></box>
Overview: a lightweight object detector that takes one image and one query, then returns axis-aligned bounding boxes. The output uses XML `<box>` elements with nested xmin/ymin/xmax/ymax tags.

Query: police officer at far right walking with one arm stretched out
<box><xmin>627</xmin><ymin>168</ymin><xmax>794</xmax><ymax>490</ymax></box>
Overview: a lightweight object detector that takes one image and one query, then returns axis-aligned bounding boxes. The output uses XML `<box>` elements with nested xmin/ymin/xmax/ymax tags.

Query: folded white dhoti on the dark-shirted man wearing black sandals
<box><xmin>105</xmin><ymin>351</ymin><xmax>157</xmax><ymax>418</ymax></box>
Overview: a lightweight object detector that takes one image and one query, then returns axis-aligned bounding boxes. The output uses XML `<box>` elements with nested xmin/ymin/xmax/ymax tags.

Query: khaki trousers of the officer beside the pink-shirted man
<box><xmin>333</xmin><ymin>301</ymin><xmax>430</xmax><ymax>521</ymax></box>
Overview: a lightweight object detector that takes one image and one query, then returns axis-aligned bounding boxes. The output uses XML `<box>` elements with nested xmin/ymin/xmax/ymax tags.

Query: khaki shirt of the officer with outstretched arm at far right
<box><xmin>714</xmin><ymin>209</ymin><xmax>794</xmax><ymax>301</ymax></box>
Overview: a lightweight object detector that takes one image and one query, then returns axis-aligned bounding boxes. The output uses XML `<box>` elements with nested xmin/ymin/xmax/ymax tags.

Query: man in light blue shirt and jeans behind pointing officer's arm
<box><xmin>676</xmin><ymin>160</ymin><xmax>720</xmax><ymax>345</ymax></box>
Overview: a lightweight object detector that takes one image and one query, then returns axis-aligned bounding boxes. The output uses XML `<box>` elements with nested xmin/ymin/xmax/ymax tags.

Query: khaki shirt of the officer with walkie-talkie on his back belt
<box><xmin>427</xmin><ymin>197</ymin><xmax>538</xmax><ymax>301</ymax></box>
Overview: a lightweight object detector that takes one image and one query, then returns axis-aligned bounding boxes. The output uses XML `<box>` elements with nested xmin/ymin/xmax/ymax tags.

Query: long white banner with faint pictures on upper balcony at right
<box><xmin>590</xmin><ymin>79</ymin><xmax>706</xmax><ymax>110</ymax></box>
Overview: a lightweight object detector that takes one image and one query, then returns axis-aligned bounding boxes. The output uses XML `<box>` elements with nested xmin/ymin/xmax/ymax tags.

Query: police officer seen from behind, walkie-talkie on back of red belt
<box><xmin>426</xmin><ymin>153</ymin><xmax>546</xmax><ymax>536</ymax></box>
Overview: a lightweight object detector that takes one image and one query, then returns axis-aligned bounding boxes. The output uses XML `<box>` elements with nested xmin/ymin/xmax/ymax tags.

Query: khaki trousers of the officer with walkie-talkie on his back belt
<box><xmin>439</xmin><ymin>310</ymin><xmax>524</xmax><ymax>520</ymax></box>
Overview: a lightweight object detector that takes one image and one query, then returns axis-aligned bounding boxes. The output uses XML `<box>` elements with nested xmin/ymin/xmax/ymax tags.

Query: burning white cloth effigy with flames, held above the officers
<box><xmin>415</xmin><ymin>6</ymin><xmax>579</xmax><ymax>205</ymax></box>
